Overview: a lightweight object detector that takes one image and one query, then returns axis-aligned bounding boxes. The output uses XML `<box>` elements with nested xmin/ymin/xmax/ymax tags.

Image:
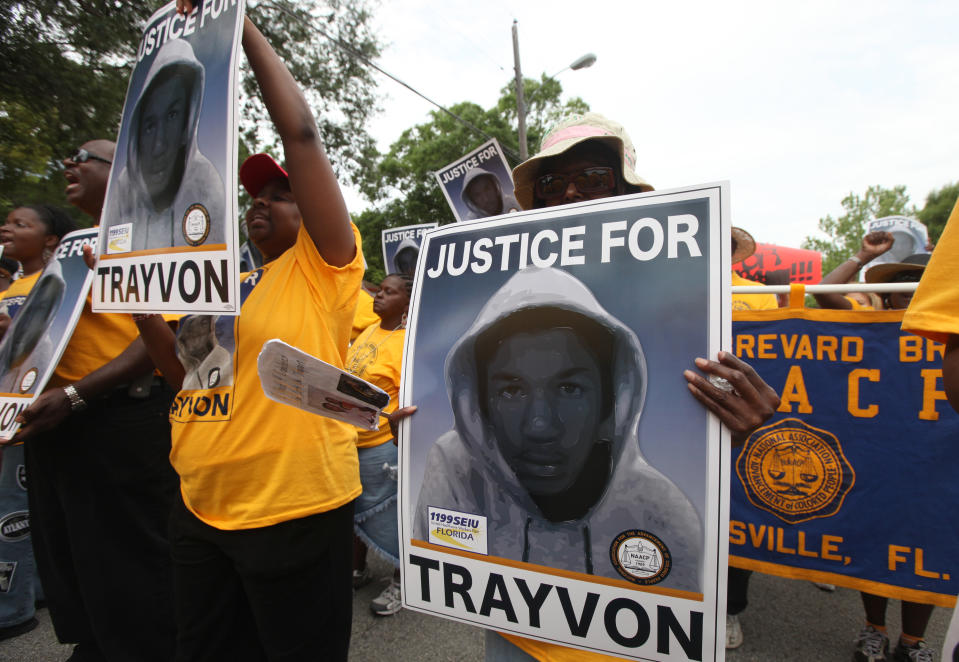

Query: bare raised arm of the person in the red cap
<box><xmin>243</xmin><ymin>18</ymin><xmax>356</xmax><ymax>267</ymax></box>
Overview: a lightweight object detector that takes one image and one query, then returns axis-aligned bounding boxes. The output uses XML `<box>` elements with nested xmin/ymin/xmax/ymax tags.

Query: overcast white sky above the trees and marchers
<box><xmin>340</xmin><ymin>0</ymin><xmax>959</xmax><ymax>246</ymax></box>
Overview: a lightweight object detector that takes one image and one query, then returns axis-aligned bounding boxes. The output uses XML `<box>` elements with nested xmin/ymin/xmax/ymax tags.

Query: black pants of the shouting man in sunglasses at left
<box><xmin>25</xmin><ymin>385</ymin><xmax>179</xmax><ymax>662</ymax></box>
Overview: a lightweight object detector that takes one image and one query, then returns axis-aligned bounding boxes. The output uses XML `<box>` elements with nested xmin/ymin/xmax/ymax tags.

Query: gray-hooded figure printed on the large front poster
<box><xmin>413</xmin><ymin>268</ymin><xmax>703</xmax><ymax>592</ymax></box>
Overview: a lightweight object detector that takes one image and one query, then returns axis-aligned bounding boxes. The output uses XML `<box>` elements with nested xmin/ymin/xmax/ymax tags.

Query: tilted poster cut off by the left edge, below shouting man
<box><xmin>0</xmin><ymin>228</ymin><xmax>97</xmax><ymax>439</ymax></box>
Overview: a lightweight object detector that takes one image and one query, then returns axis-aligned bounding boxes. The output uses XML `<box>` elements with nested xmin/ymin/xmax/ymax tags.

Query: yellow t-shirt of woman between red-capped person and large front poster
<box><xmin>346</xmin><ymin>318</ymin><xmax>406</xmax><ymax>448</ymax></box>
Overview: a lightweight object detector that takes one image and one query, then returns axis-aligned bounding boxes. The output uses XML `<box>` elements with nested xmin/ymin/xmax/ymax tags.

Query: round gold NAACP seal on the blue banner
<box><xmin>736</xmin><ymin>418</ymin><xmax>856</xmax><ymax>524</ymax></box>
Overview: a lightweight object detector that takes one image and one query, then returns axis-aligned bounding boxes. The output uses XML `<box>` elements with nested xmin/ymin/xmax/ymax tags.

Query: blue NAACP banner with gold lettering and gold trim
<box><xmin>729</xmin><ymin>308</ymin><xmax>959</xmax><ymax>606</ymax></box>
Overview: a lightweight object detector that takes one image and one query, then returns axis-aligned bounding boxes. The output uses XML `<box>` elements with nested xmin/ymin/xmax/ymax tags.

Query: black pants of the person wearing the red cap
<box><xmin>170</xmin><ymin>500</ymin><xmax>353</xmax><ymax>662</ymax></box>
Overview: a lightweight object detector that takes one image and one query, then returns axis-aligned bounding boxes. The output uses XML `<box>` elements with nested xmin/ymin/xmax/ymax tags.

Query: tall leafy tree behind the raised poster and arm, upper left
<box><xmin>0</xmin><ymin>0</ymin><xmax>379</xmax><ymax>223</ymax></box>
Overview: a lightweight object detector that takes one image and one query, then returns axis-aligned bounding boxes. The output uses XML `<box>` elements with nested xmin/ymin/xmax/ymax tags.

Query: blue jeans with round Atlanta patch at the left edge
<box><xmin>0</xmin><ymin>444</ymin><xmax>39</xmax><ymax>628</ymax></box>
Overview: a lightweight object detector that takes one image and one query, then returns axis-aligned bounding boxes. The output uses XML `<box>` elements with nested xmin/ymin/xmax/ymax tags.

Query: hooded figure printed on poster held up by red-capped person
<box><xmin>104</xmin><ymin>39</ymin><xmax>226</xmax><ymax>253</ymax></box>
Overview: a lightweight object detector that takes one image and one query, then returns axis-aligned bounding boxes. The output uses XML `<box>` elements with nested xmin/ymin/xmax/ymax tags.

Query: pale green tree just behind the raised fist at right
<box><xmin>802</xmin><ymin>186</ymin><xmax>916</xmax><ymax>274</ymax></box>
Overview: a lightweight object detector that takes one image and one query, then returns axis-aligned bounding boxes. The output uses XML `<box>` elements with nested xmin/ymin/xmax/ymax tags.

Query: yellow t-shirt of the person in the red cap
<box><xmin>170</xmin><ymin>227</ymin><xmax>363</xmax><ymax>530</ymax></box>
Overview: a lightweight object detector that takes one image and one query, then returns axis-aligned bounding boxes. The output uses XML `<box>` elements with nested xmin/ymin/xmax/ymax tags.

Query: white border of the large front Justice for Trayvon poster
<box><xmin>398</xmin><ymin>182</ymin><xmax>732</xmax><ymax>660</ymax></box>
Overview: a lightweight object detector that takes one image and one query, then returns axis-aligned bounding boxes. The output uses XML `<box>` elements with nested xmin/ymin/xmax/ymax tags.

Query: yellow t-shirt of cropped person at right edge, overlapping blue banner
<box><xmin>902</xmin><ymin>202</ymin><xmax>959</xmax><ymax>343</ymax></box>
